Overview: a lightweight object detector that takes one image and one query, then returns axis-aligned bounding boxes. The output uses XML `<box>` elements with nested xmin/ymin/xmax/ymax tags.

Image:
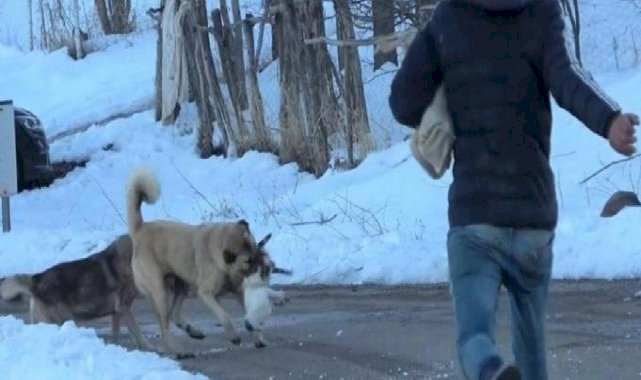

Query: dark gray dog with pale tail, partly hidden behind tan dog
<box><xmin>0</xmin><ymin>235</ymin><xmax>198</xmax><ymax>349</ymax></box>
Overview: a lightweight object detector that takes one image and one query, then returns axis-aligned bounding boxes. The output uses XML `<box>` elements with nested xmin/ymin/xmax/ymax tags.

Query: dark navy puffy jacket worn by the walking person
<box><xmin>389</xmin><ymin>0</ymin><xmax>620</xmax><ymax>229</ymax></box>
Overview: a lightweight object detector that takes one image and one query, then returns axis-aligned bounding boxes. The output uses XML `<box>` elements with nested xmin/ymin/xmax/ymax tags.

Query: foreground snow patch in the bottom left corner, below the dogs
<box><xmin>0</xmin><ymin>316</ymin><xmax>206</xmax><ymax>380</ymax></box>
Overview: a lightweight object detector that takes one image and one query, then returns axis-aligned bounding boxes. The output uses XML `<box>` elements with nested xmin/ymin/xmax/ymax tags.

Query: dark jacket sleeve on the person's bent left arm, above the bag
<box><xmin>389</xmin><ymin>22</ymin><xmax>442</xmax><ymax>128</ymax></box>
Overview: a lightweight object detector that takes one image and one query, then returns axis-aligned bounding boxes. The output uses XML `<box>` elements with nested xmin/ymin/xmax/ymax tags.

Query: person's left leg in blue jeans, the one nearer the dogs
<box><xmin>447</xmin><ymin>226</ymin><xmax>505</xmax><ymax>380</ymax></box>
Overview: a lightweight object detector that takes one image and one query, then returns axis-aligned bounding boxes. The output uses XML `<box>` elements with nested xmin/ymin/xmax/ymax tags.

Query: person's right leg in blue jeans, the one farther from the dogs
<box><xmin>505</xmin><ymin>230</ymin><xmax>554</xmax><ymax>380</ymax></box>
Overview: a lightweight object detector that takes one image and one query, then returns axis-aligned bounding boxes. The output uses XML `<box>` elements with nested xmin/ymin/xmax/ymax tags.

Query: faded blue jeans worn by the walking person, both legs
<box><xmin>447</xmin><ymin>225</ymin><xmax>554</xmax><ymax>380</ymax></box>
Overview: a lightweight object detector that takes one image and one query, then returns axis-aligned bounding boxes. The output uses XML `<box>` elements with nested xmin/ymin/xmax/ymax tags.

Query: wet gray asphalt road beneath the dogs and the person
<box><xmin>0</xmin><ymin>280</ymin><xmax>641</xmax><ymax>380</ymax></box>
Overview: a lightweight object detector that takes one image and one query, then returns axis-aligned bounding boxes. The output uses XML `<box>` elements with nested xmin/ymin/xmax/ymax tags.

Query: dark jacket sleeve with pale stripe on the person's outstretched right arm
<box><xmin>543</xmin><ymin>0</ymin><xmax>621</xmax><ymax>138</ymax></box>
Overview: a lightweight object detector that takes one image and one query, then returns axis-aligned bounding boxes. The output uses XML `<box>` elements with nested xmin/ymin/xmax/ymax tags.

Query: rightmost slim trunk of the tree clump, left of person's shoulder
<box><xmin>334</xmin><ymin>0</ymin><xmax>373</xmax><ymax>167</ymax></box>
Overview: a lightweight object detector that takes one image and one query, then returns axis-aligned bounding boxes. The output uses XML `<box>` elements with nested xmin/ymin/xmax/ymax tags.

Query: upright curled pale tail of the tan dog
<box><xmin>127</xmin><ymin>168</ymin><xmax>160</xmax><ymax>239</ymax></box>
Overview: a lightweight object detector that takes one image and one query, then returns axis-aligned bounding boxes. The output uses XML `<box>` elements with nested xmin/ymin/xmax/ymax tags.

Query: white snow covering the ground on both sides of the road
<box><xmin>0</xmin><ymin>0</ymin><xmax>641</xmax><ymax>378</ymax></box>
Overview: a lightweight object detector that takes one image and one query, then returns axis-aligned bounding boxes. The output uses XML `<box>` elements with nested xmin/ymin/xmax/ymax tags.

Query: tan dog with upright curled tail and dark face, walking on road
<box><xmin>127</xmin><ymin>169</ymin><xmax>259</xmax><ymax>355</ymax></box>
